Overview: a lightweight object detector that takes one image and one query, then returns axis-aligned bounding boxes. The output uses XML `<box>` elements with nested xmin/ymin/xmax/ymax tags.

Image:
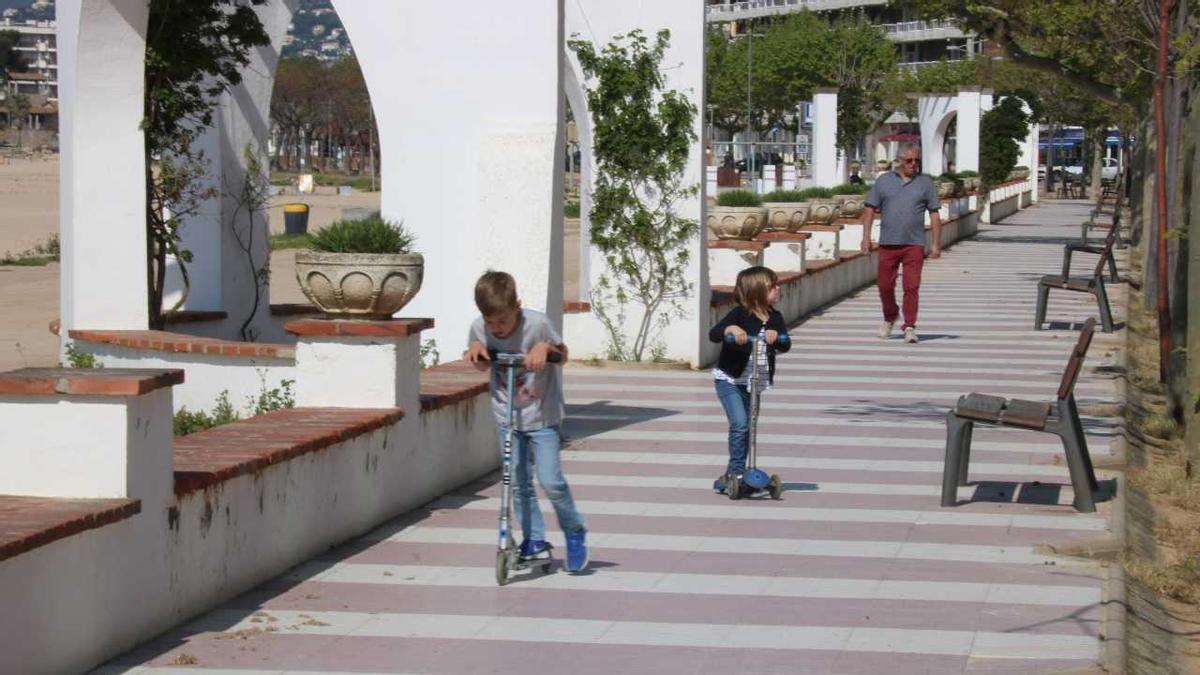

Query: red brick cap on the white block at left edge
<box><xmin>0</xmin><ymin>368</ymin><xmax>184</xmax><ymax>396</ymax></box>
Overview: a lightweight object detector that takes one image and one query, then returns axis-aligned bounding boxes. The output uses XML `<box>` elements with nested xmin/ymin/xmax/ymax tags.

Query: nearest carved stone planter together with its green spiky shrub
<box><xmin>296</xmin><ymin>213</ymin><xmax>425</xmax><ymax>319</ymax></box>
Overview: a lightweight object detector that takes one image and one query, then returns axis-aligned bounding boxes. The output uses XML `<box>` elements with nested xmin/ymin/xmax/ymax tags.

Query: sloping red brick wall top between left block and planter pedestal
<box><xmin>174</xmin><ymin>408</ymin><xmax>404</xmax><ymax>495</ymax></box>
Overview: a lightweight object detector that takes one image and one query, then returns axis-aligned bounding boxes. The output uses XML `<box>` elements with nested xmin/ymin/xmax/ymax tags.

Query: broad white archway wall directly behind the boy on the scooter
<box><xmin>334</xmin><ymin>0</ymin><xmax>563</xmax><ymax>353</ymax></box>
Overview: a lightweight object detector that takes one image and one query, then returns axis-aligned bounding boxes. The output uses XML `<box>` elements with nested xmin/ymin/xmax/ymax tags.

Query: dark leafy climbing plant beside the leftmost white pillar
<box><xmin>142</xmin><ymin>0</ymin><xmax>270</xmax><ymax>328</ymax></box>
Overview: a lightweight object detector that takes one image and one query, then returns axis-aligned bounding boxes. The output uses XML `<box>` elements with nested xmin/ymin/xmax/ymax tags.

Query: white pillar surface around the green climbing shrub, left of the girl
<box><xmin>563</xmin><ymin>0</ymin><xmax>709</xmax><ymax>364</ymax></box>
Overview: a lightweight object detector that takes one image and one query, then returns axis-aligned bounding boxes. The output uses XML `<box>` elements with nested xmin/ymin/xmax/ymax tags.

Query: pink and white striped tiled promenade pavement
<box><xmin>102</xmin><ymin>198</ymin><xmax>1123</xmax><ymax>675</ymax></box>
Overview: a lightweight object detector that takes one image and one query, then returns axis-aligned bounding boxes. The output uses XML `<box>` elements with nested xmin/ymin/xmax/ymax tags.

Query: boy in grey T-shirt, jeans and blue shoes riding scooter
<box><xmin>463</xmin><ymin>271</ymin><xmax>588</xmax><ymax>573</ymax></box>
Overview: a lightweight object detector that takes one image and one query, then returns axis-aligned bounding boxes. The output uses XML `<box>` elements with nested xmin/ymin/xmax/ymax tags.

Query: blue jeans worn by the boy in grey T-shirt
<box><xmin>497</xmin><ymin>424</ymin><xmax>583</xmax><ymax>542</ymax></box>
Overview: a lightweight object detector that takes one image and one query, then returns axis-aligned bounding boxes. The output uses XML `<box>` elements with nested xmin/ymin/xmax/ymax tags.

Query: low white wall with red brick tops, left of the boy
<box><xmin>0</xmin><ymin>325</ymin><xmax>499</xmax><ymax>674</ymax></box>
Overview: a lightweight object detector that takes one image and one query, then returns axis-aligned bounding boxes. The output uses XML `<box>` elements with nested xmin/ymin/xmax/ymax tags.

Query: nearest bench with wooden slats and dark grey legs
<box><xmin>942</xmin><ymin>318</ymin><xmax>1097</xmax><ymax>513</ymax></box>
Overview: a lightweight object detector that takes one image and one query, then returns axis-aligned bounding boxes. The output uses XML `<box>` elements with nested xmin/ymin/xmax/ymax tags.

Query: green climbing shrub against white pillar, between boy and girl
<box><xmin>568</xmin><ymin>30</ymin><xmax>700</xmax><ymax>360</ymax></box>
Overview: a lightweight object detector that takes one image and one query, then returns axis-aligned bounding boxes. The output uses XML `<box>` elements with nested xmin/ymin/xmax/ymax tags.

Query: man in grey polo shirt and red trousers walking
<box><xmin>863</xmin><ymin>145</ymin><xmax>942</xmax><ymax>344</ymax></box>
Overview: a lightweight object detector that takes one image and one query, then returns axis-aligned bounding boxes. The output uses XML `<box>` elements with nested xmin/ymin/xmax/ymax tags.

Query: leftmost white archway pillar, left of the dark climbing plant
<box><xmin>56</xmin><ymin>0</ymin><xmax>149</xmax><ymax>335</ymax></box>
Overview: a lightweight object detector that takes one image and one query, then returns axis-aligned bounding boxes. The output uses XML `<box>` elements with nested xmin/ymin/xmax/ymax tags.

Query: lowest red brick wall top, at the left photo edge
<box><xmin>0</xmin><ymin>495</ymin><xmax>142</xmax><ymax>561</ymax></box>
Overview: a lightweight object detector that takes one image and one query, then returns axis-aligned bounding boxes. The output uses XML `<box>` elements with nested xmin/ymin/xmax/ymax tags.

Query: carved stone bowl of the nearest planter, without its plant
<box><xmin>296</xmin><ymin>251</ymin><xmax>425</xmax><ymax>321</ymax></box>
